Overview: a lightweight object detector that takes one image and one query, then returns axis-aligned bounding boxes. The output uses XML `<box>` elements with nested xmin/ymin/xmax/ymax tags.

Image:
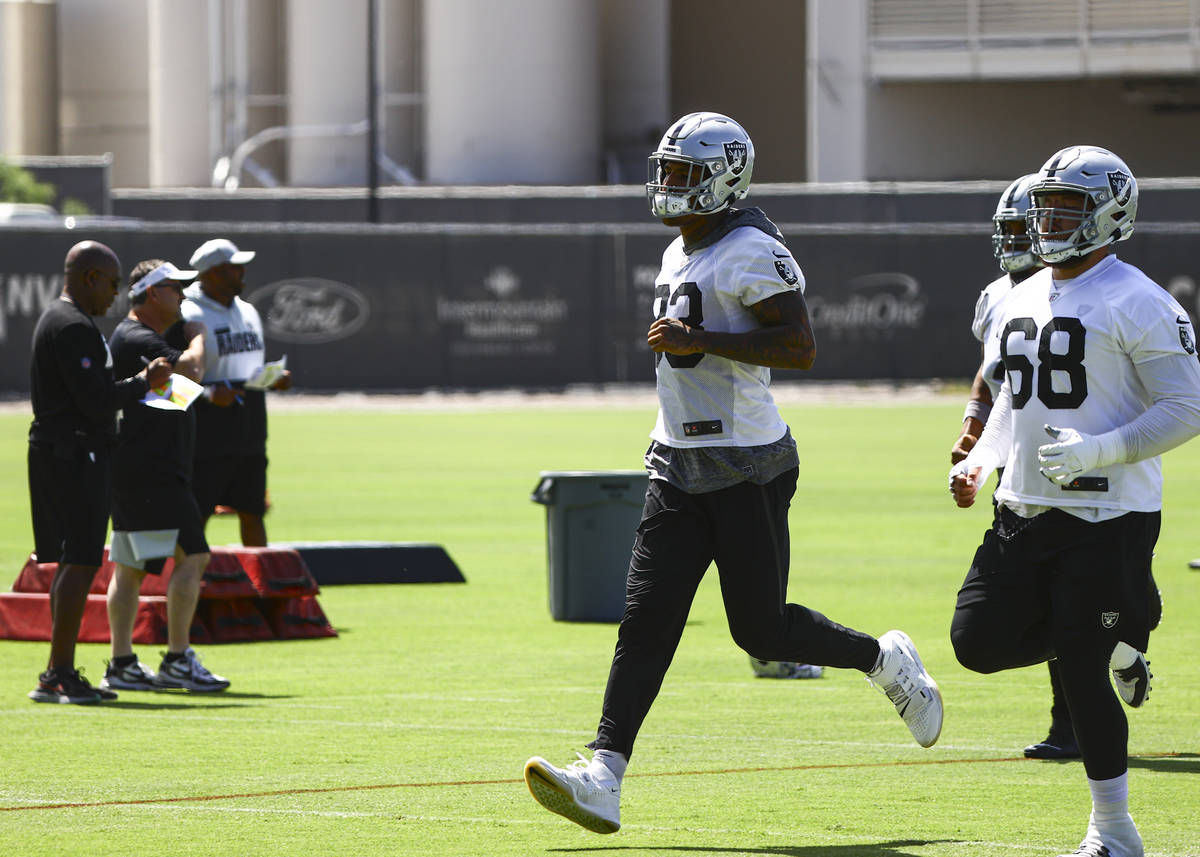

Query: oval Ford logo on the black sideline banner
<box><xmin>246</xmin><ymin>277</ymin><xmax>371</xmax><ymax>344</ymax></box>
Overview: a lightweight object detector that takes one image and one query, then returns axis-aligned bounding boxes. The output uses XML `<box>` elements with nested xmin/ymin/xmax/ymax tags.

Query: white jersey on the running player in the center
<box><xmin>650</xmin><ymin>220</ymin><xmax>804</xmax><ymax>447</ymax></box>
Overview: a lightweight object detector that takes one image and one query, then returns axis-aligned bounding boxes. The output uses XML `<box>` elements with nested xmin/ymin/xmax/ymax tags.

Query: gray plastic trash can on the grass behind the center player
<box><xmin>529</xmin><ymin>471</ymin><xmax>649</xmax><ymax>622</ymax></box>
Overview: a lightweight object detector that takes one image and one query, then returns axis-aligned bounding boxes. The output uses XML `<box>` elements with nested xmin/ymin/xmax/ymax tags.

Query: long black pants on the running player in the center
<box><xmin>589</xmin><ymin>468</ymin><xmax>880</xmax><ymax>756</ymax></box>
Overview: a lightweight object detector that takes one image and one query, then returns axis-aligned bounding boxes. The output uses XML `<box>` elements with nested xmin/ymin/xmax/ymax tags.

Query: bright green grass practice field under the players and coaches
<box><xmin>0</xmin><ymin>395</ymin><xmax>1200</xmax><ymax>857</ymax></box>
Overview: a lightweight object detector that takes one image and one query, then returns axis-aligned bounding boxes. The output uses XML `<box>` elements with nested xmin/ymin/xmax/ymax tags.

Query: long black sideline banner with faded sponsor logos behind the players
<box><xmin>0</xmin><ymin>223</ymin><xmax>1200</xmax><ymax>395</ymax></box>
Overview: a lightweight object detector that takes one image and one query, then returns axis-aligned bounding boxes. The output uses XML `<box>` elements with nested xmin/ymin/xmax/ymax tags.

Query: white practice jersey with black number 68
<box><xmin>994</xmin><ymin>250</ymin><xmax>1195</xmax><ymax>517</ymax></box>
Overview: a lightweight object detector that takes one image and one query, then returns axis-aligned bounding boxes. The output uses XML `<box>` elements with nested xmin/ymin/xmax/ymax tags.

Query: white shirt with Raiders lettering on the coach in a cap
<box><xmin>180</xmin><ymin>282</ymin><xmax>266</xmax><ymax>384</ymax></box>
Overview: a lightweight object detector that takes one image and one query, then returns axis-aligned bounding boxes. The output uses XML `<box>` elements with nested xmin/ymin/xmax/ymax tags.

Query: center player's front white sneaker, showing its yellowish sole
<box><xmin>524</xmin><ymin>756</ymin><xmax>620</xmax><ymax>833</ymax></box>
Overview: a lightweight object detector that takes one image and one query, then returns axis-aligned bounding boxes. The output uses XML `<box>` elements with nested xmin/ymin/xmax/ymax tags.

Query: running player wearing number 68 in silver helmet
<box><xmin>950</xmin><ymin>146</ymin><xmax>1200</xmax><ymax>857</ymax></box>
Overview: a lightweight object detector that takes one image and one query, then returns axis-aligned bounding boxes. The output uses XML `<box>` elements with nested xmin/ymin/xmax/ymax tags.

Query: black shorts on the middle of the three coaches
<box><xmin>113</xmin><ymin>456</ymin><xmax>209</xmax><ymax>556</ymax></box>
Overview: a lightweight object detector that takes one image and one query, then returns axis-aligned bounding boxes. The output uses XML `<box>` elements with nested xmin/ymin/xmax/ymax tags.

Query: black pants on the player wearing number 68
<box><xmin>950</xmin><ymin>507</ymin><xmax>1162</xmax><ymax>780</ymax></box>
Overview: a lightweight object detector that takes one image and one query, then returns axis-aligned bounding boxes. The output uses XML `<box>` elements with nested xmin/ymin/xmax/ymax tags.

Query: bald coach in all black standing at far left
<box><xmin>29</xmin><ymin>241</ymin><xmax>170</xmax><ymax>705</ymax></box>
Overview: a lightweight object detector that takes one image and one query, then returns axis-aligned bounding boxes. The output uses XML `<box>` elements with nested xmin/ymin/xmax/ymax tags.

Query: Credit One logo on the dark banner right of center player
<box><xmin>808</xmin><ymin>271</ymin><xmax>926</xmax><ymax>338</ymax></box>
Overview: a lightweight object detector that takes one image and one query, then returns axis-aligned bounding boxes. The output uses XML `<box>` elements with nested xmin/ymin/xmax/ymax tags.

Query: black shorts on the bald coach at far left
<box><xmin>29</xmin><ymin>442</ymin><xmax>112</xmax><ymax>568</ymax></box>
